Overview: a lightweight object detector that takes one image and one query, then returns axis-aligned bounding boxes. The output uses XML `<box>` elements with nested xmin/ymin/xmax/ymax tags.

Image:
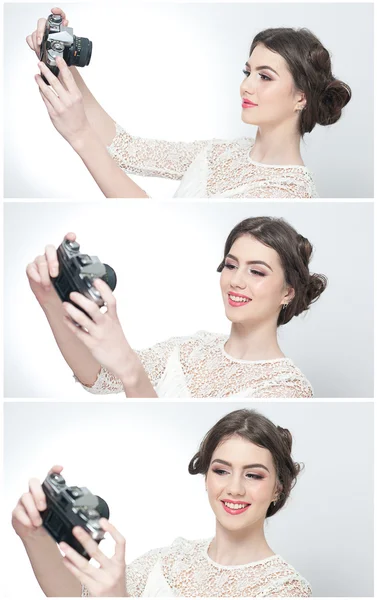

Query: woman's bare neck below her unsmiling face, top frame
<box><xmin>250</xmin><ymin>121</ymin><xmax>304</xmax><ymax>166</ymax></box>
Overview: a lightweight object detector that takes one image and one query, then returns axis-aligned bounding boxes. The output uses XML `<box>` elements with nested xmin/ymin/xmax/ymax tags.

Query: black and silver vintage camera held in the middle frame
<box><xmin>52</xmin><ymin>240</ymin><xmax>117</xmax><ymax>312</ymax></box>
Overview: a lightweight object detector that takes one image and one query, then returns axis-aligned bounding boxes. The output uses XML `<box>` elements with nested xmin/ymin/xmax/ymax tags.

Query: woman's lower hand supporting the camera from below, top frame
<box><xmin>35</xmin><ymin>57</ymin><xmax>94</xmax><ymax>148</ymax></box>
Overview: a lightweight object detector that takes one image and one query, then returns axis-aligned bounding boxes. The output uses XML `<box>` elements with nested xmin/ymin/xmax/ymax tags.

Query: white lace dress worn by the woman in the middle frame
<box><xmin>77</xmin><ymin>331</ymin><xmax>313</xmax><ymax>398</ymax></box>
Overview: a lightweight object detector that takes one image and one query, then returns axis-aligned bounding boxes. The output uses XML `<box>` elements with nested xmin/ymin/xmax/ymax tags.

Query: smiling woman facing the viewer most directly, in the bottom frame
<box><xmin>12</xmin><ymin>409</ymin><xmax>311</xmax><ymax>597</ymax></box>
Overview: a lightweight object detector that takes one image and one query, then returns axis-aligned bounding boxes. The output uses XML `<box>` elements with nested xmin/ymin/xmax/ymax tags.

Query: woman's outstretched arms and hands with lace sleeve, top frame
<box><xmin>27</xmin><ymin>8</ymin><xmax>209</xmax><ymax>198</ymax></box>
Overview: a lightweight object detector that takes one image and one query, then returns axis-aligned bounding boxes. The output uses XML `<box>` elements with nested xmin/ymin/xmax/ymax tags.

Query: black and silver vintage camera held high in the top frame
<box><xmin>40</xmin><ymin>14</ymin><xmax>93</xmax><ymax>84</ymax></box>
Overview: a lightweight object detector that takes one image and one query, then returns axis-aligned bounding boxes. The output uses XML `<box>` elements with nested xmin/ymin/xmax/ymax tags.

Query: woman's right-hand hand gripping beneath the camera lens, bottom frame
<box><xmin>59</xmin><ymin>518</ymin><xmax>126</xmax><ymax>598</ymax></box>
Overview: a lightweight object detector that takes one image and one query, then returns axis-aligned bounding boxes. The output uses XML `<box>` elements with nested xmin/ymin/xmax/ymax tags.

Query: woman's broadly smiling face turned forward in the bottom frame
<box><xmin>206</xmin><ymin>435</ymin><xmax>280</xmax><ymax>531</ymax></box>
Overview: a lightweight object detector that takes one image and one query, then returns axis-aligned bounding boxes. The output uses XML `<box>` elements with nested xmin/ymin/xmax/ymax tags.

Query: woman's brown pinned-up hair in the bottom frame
<box><xmin>188</xmin><ymin>408</ymin><xmax>303</xmax><ymax>517</ymax></box>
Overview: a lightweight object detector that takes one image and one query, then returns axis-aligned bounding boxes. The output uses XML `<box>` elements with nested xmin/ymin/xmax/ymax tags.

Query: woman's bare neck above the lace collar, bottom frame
<box><xmin>208</xmin><ymin>522</ymin><xmax>274</xmax><ymax>566</ymax></box>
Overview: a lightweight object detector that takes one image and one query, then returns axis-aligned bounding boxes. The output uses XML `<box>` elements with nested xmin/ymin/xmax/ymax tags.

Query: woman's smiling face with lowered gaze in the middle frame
<box><xmin>220</xmin><ymin>234</ymin><xmax>294</xmax><ymax>326</ymax></box>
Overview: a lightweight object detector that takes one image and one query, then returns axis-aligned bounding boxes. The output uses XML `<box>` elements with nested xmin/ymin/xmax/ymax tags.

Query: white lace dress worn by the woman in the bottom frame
<box><xmin>82</xmin><ymin>538</ymin><xmax>311</xmax><ymax>598</ymax></box>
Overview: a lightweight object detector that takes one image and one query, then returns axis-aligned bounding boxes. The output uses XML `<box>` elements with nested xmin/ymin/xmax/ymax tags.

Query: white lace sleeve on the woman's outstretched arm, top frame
<box><xmin>107</xmin><ymin>123</ymin><xmax>211</xmax><ymax>179</ymax></box>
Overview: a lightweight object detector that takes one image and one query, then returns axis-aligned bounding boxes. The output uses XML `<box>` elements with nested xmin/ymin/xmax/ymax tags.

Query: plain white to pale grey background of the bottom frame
<box><xmin>2</xmin><ymin>402</ymin><xmax>373</xmax><ymax>598</ymax></box>
